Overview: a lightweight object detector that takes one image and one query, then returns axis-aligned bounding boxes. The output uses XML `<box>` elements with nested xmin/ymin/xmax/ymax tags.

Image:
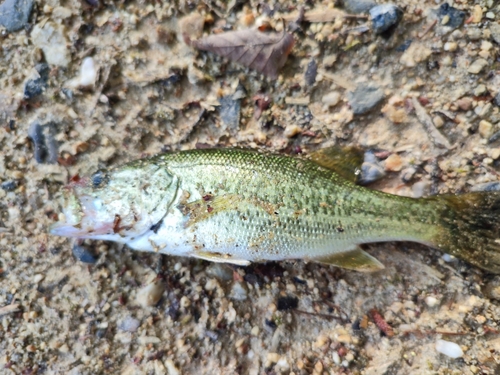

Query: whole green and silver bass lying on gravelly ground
<box><xmin>50</xmin><ymin>146</ymin><xmax>500</xmax><ymax>274</ymax></box>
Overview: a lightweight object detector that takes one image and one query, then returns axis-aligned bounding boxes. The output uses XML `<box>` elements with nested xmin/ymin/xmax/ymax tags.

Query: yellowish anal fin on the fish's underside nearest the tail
<box><xmin>312</xmin><ymin>248</ymin><xmax>385</xmax><ymax>272</ymax></box>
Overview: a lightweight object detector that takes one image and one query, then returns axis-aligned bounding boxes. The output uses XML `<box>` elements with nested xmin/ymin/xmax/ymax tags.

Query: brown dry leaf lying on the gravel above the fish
<box><xmin>191</xmin><ymin>30</ymin><xmax>295</xmax><ymax>79</ymax></box>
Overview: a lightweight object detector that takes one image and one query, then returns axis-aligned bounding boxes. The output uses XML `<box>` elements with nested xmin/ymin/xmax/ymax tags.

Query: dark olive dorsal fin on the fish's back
<box><xmin>310</xmin><ymin>146</ymin><xmax>364</xmax><ymax>183</ymax></box>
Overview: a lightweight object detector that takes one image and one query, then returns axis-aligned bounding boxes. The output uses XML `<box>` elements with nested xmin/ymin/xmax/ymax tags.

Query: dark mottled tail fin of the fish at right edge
<box><xmin>427</xmin><ymin>192</ymin><xmax>500</xmax><ymax>274</ymax></box>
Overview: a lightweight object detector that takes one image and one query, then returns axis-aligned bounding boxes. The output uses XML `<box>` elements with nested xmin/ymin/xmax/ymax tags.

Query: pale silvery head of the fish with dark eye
<box><xmin>50</xmin><ymin>160</ymin><xmax>178</xmax><ymax>242</ymax></box>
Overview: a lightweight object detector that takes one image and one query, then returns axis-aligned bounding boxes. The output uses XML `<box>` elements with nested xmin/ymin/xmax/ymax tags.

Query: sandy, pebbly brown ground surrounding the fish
<box><xmin>0</xmin><ymin>0</ymin><xmax>500</xmax><ymax>375</ymax></box>
